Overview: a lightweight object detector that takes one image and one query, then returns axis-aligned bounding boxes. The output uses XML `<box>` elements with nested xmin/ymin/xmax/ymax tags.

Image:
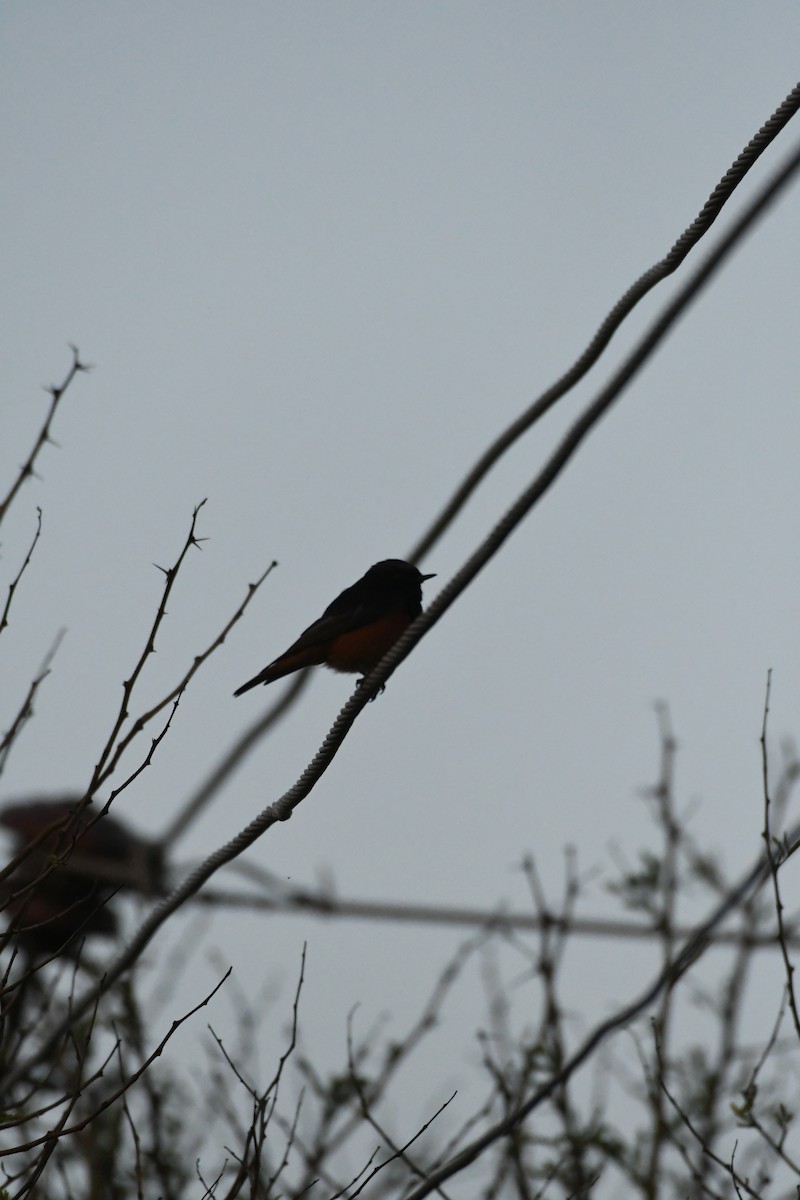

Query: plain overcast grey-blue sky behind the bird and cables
<box><xmin>0</xmin><ymin>0</ymin><xmax>800</xmax><ymax>1190</ymax></box>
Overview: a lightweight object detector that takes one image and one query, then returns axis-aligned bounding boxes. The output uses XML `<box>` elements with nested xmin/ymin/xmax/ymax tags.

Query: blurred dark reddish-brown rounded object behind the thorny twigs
<box><xmin>0</xmin><ymin>796</ymin><xmax>164</xmax><ymax>956</ymax></box>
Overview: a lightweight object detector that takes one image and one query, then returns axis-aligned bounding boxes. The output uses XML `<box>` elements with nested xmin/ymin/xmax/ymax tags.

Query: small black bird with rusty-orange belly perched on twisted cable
<box><xmin>234</xmin><ymin>558</ymin><xmax>434</xmax><ymax>696</ymax></box>
